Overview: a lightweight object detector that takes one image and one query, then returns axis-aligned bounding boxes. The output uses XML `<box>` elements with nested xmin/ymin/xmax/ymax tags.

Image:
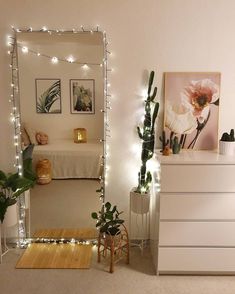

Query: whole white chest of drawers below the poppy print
<box><xmin>158</xmin><ymin>151</ymin><xmax>235</xmax><ymax>274</ymax></box>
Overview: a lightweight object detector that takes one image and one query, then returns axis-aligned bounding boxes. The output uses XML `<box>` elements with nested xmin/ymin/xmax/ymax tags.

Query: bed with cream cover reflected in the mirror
<box><xmin>33</xmin><ymin>139</ymin><xmax>103</xmax><ymax>179</ymax></box>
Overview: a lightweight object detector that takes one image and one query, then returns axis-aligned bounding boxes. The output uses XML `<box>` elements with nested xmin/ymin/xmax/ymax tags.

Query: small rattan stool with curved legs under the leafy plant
<box><xmin>98</xmin><ymin>225</ymin><xmax>130</xmax><ymax>273</ymax></box>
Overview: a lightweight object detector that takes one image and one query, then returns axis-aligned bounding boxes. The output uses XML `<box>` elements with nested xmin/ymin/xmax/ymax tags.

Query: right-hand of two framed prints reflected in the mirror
<box><xmin>70</xmin><ymin>79</ymin><xmax>95</xmax><ymax>114</ymax></box>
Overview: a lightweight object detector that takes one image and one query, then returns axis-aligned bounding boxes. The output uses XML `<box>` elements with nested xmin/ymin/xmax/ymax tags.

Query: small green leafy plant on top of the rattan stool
<box><xmin>91</xmin><ymin>202</ymin><xmax>124</xmax><ymax>235</ymax></box>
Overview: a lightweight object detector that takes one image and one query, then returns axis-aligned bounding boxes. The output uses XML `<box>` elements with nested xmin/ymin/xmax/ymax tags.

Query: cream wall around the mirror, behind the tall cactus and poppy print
<box><xmin>0</xmin><ymin>0</ymin><xmax>235</xmax><ymax>217</ymax></box>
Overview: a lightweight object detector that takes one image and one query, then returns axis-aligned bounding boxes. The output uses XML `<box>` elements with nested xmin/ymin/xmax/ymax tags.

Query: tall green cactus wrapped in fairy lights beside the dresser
<box><xmin>136</xmin><ymin>71</ymin><xmax>159</xmax><ymax>193</ymax></box>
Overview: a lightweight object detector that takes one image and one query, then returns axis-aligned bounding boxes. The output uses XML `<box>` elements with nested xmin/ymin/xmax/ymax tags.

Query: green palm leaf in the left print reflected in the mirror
<box><xmin>37</xmin><ymin>81</ymin><xmax>60</xmax><ymax>113</ymax></box>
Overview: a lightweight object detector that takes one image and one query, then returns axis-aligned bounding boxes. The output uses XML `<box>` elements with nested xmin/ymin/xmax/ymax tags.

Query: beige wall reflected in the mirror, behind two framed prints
<box><xmin>17</xmin><ymin>33</ymin><xmax>104</xmax><ymax>141</ymax></box>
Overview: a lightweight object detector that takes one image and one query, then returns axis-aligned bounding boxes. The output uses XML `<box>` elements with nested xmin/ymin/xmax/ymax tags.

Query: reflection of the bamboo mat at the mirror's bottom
<box><xmin>33</xmin><ymin>228</ymin><xmax>98</xmax><ymax>240</ymax></box>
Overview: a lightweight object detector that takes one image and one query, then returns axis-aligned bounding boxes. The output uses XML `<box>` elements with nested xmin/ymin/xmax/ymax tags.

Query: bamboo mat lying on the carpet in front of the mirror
<box><xmin>16</xmin><ymin>243</ymin><xmax>92</xmax><ymax>269</ymax></box>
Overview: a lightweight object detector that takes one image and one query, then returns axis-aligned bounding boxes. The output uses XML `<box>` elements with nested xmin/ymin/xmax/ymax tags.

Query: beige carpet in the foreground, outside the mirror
<box><xmin>0</xmin><ymin>247</ymin><xmax>235</xmax><ymax>294</ymax></box>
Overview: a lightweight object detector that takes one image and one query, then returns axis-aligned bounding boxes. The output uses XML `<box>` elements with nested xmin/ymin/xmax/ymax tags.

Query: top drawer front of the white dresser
<box><xmin>161</xmin><ymin>165</ymin><xmax>235</xmax><ymax>192</ymax></box>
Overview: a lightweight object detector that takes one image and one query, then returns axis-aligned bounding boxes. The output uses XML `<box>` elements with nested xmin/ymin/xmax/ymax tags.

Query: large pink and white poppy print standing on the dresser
<box><xmin>164</xmin><ymin>72</ymin><xmax>220</xmax><ymax>150</ymax></box>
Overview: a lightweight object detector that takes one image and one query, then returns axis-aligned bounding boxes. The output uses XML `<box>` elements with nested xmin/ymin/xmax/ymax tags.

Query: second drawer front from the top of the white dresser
<box><xmin>160</xmin><ymin>193</ymin><xmax>235</xmax><ymax>220</ymax></box>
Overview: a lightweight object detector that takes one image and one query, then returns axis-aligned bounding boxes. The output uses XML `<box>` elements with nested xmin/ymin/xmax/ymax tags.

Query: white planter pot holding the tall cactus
<box><xmin>130</xmin><ymin>188</ymin><xmax>150</xmax><ymax>214</ymax></box>
